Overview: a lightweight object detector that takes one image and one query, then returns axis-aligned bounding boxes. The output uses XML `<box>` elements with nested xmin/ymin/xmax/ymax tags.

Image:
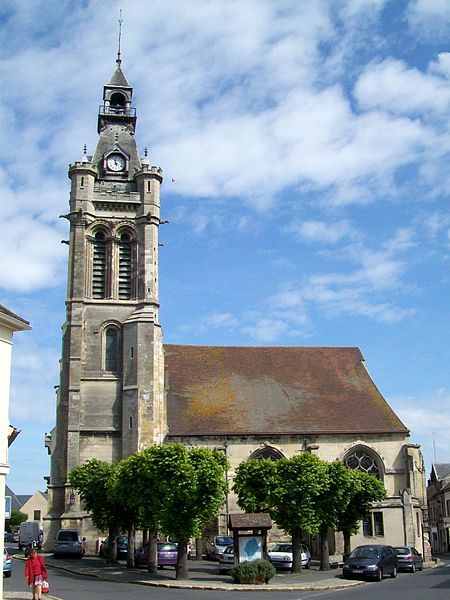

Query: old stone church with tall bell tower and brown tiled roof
<box><xmin>44</xmin><ymin>52</ymin><xmax>427</xmax><ymax>555</ymax></box>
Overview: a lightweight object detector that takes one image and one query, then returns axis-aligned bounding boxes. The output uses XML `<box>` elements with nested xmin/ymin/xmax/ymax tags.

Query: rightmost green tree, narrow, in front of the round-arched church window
<box><xmin>336</xmin><ymin>470</ymin><xmax>387</xmax><ymax>557</ymax></box>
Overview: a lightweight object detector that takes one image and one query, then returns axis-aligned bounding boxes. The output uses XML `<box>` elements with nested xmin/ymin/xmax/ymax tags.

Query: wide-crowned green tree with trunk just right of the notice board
<box><xmin>233</xmin><ymin>452</ymin><xmax>328</xmax><ymax>573</ymax></box>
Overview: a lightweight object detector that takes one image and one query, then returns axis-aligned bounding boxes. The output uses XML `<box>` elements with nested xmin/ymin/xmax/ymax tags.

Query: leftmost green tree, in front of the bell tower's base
<box><xmin>69</xmin><ymin>458</ymin><xmax>127</xmax><ymax>562</ymax></box>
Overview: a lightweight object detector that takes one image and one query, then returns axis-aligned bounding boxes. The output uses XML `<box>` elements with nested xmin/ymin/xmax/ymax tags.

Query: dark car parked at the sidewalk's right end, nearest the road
<box><xmin>342</xmin><ymin>544</ymin><xmax>398</xmax><ymax>581</ymax></box>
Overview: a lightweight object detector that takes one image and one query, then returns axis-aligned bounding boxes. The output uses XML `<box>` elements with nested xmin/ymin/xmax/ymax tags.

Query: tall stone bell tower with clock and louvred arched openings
<box><xmin>45</xmin><ymin>52</ymin><xmax>167</xmax><ymax>544</ymax></box>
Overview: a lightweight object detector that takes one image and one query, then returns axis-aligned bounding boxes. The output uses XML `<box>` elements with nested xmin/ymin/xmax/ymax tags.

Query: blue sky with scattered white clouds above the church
<box><xmin>0</xmin><ymin>0</ymin><xmax>450</xmax><ymax>493</ymax></box>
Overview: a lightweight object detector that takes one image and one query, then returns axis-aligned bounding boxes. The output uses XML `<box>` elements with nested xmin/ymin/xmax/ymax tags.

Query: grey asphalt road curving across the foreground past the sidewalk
<box><xmin>3</xmin><ymin>548</ymin><xmax>450</xmax><ymax>600</ymax></box>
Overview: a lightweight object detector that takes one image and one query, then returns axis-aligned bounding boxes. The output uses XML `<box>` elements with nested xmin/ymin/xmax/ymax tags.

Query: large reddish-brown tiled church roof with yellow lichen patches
<box><xmin>164</xmin><ymin>344</ymin><xmax>408</xmax><ymax>436</ymax></box>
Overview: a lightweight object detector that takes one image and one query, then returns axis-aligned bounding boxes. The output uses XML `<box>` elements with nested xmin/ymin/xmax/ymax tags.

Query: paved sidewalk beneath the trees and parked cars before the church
<box><xmin>14</xmin><ymin>554</ymin><xmax>364</xmax><ymax>592</ymax></box>
